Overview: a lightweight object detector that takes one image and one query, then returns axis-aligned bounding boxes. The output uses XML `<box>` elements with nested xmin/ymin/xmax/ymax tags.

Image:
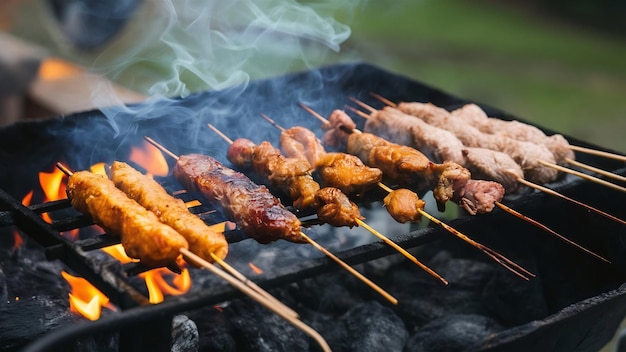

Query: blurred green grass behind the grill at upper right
<box><xmin>336</xmin><ymin>0</ymin><xmax>626</xmax><ymax>152</ymax></box>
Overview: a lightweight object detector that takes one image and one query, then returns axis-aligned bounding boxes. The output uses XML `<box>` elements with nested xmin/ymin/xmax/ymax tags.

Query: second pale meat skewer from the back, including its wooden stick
<box><xmin>366</xmin><ymin>98</ymin><xmax>626</xmax><ymax>192</ymax></box>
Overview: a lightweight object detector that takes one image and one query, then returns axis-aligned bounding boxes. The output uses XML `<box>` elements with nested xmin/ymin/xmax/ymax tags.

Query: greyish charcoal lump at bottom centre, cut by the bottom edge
<box><xmin>314</xmin><ymin>301</ymin><xmax>408</xmax><ymax>352</ymax></box>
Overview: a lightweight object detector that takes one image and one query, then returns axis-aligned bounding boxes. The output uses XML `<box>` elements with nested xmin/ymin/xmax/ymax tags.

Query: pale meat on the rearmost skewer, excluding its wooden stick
<box><xmin>451</xmin><ymin>104</ymin><xmax>575</xmax><ymax>165</ymax></box>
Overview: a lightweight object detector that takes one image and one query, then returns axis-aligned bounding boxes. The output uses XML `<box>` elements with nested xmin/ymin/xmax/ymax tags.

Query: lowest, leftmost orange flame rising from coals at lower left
<box><xmin>61</xmin><ymin>271</ymin><xmax>115</xmax><ymax>321</ymax></box>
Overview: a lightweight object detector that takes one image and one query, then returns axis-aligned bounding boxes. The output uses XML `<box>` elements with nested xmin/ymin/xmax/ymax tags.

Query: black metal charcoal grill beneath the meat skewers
<box><xmin>0</xmin><ymin>63</ymin><xmax>626</xmax><ymax>351</ymax></box>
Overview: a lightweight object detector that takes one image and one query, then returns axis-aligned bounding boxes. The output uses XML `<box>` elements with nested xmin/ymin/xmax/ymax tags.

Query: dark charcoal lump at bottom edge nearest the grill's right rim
<box><xmin>404</xmin><ymin>314</ymin><xmax>502</xmax><ymax>352</ymax></box>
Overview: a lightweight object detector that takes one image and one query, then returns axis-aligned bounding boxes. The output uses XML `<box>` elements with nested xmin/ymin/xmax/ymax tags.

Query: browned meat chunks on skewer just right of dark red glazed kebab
<box><xmin>227</xmin><ymin>138</ymin><xmax>363</xmax><ymax>227</ymax></box>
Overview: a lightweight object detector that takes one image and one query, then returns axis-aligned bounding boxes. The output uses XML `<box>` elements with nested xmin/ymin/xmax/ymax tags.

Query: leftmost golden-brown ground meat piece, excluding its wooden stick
<box><xmin>67</xmin><ymin>171</ymin><xmax>189</xmax><ymax>266</ymax></box>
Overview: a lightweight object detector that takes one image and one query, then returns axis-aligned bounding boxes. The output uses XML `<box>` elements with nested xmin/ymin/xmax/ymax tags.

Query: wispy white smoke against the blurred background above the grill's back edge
<box><xmin>84</xmin><ymin>0</ymin><xmax>356</xmax><ymax>97</ymax></box>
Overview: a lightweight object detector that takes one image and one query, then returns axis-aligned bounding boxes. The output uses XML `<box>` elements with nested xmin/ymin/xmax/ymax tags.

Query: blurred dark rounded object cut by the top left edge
<box><xmin>47</xmin><ymin>0</ymin><xmax>142</xmax><ymax>50</ymax></box>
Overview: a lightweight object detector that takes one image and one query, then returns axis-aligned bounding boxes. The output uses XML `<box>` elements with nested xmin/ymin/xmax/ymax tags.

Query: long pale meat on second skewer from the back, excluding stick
<box><xmin>392</xmin><ymin>102</ymin><xmax>558</xmax><ymax>184</ymax></box>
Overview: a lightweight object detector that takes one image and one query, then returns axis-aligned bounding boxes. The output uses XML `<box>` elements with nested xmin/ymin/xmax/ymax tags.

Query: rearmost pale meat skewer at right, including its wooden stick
<box><xmin>370</xmin><ymin>93</ymin><xmax>626</xmax><ymax>165</ymax></box>
